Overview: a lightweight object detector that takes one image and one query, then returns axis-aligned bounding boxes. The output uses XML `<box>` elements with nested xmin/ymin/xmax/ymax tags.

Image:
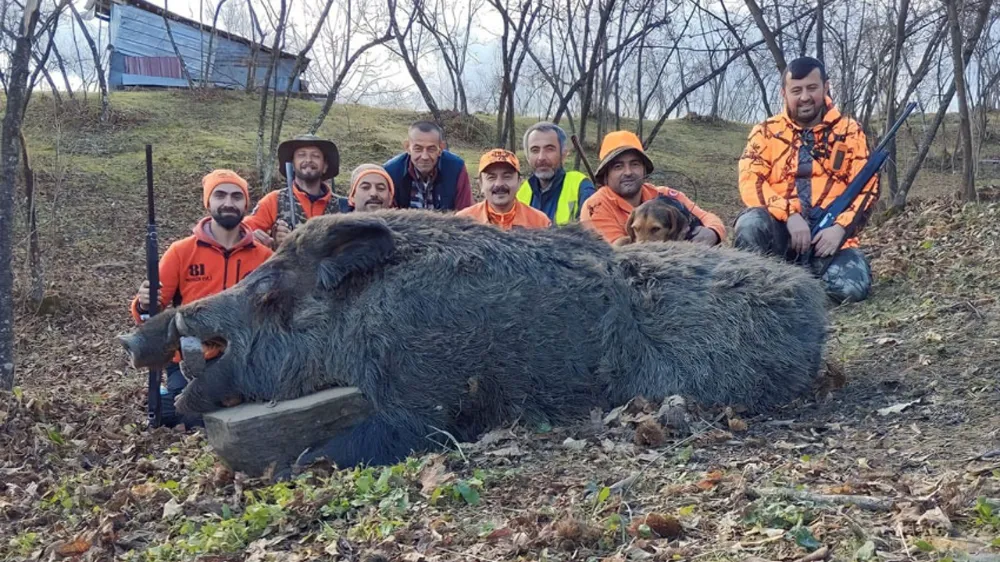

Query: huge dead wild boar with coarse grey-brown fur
<box><xmin>122</xmin><ymin>211</ymin><xmax>827</xmax><ymax>466</ymax></box>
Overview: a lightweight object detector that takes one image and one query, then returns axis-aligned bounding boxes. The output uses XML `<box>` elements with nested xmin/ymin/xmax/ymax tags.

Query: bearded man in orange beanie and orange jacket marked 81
<box><xmin>132</xmin><ymin>170</ymin><xmax>271</xmax><ymax>427</ymax></box>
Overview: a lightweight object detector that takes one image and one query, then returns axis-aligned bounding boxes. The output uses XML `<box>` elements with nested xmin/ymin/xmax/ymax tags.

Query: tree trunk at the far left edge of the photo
<box><xmin>0</xmin><ymin>2</ymin><xmax>42</xmax><ymax>390</ymax></box>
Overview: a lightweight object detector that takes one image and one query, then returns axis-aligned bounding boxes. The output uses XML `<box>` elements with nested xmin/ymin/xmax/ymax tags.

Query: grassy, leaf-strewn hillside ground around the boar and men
<box><xmin>0</xmin><ymin>92</ymin><xmax>1000</xmax><ymax>562</ymax></box>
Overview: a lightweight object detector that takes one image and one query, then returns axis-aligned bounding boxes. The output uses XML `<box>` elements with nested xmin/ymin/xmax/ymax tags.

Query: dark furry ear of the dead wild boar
<box><xmin>316</xmin><ymin>218</ymin><xmax>395</xmax><ymax>290</ymax></box>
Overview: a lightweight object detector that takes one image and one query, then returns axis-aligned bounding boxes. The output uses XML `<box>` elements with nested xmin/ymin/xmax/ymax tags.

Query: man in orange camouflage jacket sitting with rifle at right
<box><xmin>733</xmin><ymin>57</ymin><xmax>878</xmax><ymax>303</ymax></box>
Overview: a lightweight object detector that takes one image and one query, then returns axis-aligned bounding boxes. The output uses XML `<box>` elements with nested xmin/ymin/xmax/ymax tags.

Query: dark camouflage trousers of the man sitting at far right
<box><xmin>733</xmin><ymin>207</ymin><xmax>872</xmax><ymax>304</ymax></box>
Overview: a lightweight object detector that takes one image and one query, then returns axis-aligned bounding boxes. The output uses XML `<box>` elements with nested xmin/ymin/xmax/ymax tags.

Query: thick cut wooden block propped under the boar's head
<box><xmin>205</xmin><ymin>387</ymin><xmax>371</xmax><ymax>477</ymax></box>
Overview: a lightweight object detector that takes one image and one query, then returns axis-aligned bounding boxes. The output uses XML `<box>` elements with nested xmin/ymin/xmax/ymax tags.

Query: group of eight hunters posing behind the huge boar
<box><xmin>132</xmin><ymin>57</ymin><xmax>878</xmax><ymax>426</ymax></box>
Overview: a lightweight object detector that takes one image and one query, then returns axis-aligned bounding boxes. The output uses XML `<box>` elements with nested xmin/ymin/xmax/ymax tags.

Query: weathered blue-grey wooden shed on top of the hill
<box><xmin>92</xmin><ymin>0</ymin><xmax>308</xmax><ymax>92</ymax></box>
